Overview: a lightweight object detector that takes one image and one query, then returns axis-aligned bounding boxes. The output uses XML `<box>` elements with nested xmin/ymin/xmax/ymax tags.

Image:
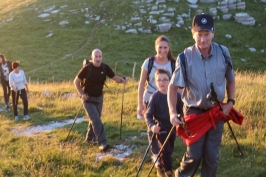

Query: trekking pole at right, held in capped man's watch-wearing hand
<box><xmin>206</xmin><ymin>82</ymin><xmax>244</xmax><ymax>156</ymax></box>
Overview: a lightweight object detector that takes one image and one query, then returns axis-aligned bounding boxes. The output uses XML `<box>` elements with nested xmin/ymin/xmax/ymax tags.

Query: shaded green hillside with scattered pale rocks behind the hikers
<box><xmin>0</xmin><ymin>0</ymin><xmax>266</xmax><ymax>82</ymax></box>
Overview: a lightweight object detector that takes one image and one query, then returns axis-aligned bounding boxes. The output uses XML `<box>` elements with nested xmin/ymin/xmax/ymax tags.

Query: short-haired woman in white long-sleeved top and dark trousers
<box><xmin>9</xmin><ymin>61</ymin><xmax>31</xmax><ymax>121</ymax></box>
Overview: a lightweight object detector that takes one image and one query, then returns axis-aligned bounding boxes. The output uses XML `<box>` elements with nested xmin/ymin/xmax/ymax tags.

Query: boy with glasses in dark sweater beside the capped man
<box><xmin>145</xmin><ymin>69</ymin><xmax>183</xmax><ymax>177</ymax></box>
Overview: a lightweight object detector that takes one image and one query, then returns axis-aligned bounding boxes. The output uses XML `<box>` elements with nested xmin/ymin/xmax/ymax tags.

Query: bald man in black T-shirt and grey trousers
<box><xmin>74</xmin><ymin>49</ymin><xmax>126</xmax><ymax>152</ymax></box>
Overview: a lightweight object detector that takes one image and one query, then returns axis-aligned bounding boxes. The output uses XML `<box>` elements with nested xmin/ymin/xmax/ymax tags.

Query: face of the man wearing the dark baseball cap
<box><xmin>193</xmin><ymin>30</ymin><xmax>214</xmax><ymax>50</ymax></box>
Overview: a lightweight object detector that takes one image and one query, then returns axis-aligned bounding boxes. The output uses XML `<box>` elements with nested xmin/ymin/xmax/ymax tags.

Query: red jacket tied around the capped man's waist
<box><xmin>176</xmin><ymin>105</ymin><xmax>244</xmax><ymax>145</ymax></box>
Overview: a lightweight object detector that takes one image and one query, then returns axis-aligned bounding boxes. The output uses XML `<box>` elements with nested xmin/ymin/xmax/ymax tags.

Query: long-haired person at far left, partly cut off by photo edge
<box><xmin>0</xmin><ymin>54</ymin><xmax>12</xmax><ymax>108</ymax></box>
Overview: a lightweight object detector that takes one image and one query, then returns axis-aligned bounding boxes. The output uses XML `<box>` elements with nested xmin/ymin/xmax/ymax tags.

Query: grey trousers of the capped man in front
<box><xmin>175</xmin><ymin>121</ymin><xmax>224</xmax><ymax>177</ymax></box>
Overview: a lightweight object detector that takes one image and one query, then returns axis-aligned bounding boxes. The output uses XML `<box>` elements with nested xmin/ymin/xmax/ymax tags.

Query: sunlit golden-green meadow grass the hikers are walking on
<box><xmin>0</xmin><ymin>72</ymin><xmax>266</xmax><ymax>177</ymax></box>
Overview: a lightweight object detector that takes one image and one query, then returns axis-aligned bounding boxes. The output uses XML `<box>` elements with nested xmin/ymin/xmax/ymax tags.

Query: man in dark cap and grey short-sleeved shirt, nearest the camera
<box><xmin>168</xmin><ymin>14</ymin><xmax>235</xmax><ymax>177</ymax></box>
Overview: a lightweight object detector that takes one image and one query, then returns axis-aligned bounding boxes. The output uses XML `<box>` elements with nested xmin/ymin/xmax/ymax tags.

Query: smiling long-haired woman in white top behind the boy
<box><xmin>137</xmin><ymin>35</ymin><xmax>175</xmax><ymax>166</ymax></box>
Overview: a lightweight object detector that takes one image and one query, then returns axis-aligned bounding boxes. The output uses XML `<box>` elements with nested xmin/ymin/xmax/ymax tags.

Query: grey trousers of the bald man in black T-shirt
<box><xmin>83</xmin><ymin>95</ymin><xmax>107</xmax><ymax>145</ymax></box>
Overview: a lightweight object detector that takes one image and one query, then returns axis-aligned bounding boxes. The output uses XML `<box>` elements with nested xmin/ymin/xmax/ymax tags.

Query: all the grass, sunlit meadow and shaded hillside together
<box><xmin>0</xmin><ymin>0</ymin><xmax>266</xmax><ymax>177</ymax></box>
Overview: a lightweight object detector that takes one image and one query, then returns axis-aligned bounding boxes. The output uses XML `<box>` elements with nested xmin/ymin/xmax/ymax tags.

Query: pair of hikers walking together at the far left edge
<box><xmin>0</xmin><ymin>54</ymin><xmax>31</xmax><ymax>121</ymax></box>
